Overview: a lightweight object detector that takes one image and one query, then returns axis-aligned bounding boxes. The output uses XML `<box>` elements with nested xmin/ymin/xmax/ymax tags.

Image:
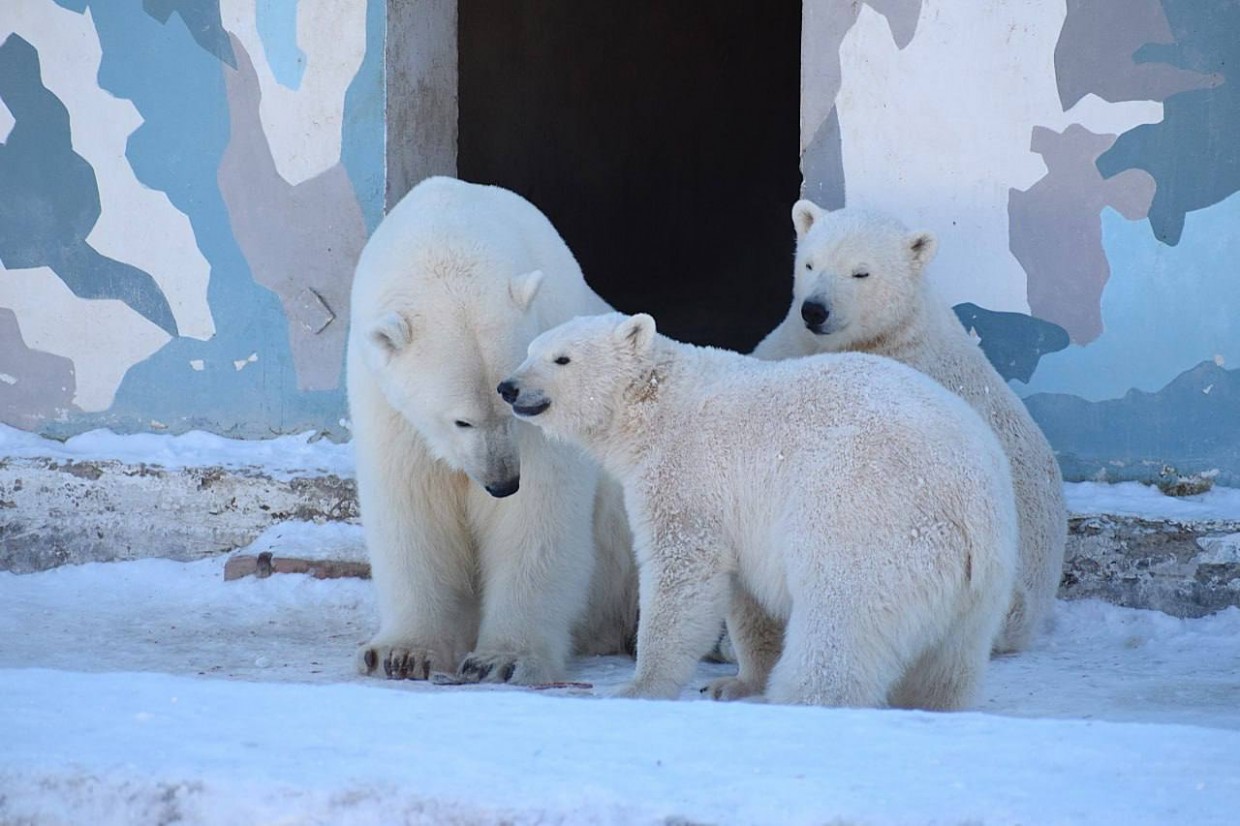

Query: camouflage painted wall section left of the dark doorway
<box><xmin>0</xmin><ymin>0</ymin><xmax>384</xmax><ymax>437</ymax></box>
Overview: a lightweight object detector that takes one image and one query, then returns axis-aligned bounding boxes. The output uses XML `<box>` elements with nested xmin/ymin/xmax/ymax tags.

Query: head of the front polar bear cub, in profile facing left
<box><xmin>497</xmin><ymin>313</ymin><xmax>655</xmax><ymax>443</ymax></box>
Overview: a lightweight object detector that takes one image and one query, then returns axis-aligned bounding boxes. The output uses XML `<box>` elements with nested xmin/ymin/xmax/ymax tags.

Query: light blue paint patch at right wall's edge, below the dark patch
<box><xmin>1029</xmin><ymin>193</ymin><xmax>1240</xmax><ymax>401</ymax></box>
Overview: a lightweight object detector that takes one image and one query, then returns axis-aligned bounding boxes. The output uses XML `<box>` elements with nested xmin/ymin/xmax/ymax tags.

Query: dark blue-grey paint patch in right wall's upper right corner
<box><xmin>1097</xmin><ymin>0</ymin><xmax>1240</xmax><ymax>246</ymax></box>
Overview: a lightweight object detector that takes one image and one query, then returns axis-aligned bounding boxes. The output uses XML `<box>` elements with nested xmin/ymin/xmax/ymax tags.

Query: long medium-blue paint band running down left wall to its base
<box><xmin>45</xmin><ymin>0</ymin><xmax>347</xmax><ymax>438</ymax></box>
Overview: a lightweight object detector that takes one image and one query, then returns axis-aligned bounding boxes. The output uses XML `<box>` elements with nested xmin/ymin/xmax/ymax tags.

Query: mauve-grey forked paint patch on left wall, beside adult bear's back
<box><xmin>218</xmin><ymin>41</ymin><xmax>366</xmax><ymax>391</ymax></box>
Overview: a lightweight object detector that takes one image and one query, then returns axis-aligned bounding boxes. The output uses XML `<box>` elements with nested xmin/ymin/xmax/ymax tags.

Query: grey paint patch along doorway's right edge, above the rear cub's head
<box><xmin>801</xmin><ymin>0</ymin><xmax>921</xmax><ymax>200</ymax></box>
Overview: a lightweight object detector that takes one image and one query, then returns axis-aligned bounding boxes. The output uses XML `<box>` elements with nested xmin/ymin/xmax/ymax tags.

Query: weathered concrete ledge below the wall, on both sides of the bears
<box><xmin>0</xmin><ymin>458</ymin><xmax>1240</xmax><ymax>616</ymax></box>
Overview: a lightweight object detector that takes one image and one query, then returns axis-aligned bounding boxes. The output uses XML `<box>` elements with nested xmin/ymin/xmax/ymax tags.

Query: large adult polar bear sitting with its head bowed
<box><xmin>348</xmin><ymin>177</ymin><xmax>636</xmax><ymax>683</ymax></box>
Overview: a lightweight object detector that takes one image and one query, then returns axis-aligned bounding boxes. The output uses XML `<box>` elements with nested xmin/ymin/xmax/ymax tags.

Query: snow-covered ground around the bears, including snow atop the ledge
<box><xmin>0</xmin><ymin>432</ymin><xmax>1240</xmax><ymax>825</ymax></box>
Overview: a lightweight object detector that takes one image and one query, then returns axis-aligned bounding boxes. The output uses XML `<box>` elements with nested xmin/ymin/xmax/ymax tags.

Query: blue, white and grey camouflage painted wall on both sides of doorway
<box><xmin>0</xmin><ymin>0</ymin><xmax>1240</xmax><ymax>485</ymax></box>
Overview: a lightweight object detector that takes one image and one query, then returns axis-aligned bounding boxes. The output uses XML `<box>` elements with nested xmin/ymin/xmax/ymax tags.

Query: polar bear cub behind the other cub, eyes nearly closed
<box><xmin>754</xmin><ymin>201</ymin><xmax>1068</xmax><ymax>652</ymax></box>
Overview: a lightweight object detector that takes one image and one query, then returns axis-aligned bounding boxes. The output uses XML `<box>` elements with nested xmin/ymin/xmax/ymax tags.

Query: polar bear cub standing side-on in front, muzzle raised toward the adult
<box><xmin>497</xmin><ymin>314</ymin><xmax>1017</xmax><ymax>709</ymax></box>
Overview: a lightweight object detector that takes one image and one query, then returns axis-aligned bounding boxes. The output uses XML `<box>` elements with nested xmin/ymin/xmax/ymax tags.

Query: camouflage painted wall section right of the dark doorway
<box><xmin>801</xmin><ymin>0</ymin><xmax>1240</xmax><ymax>485</ymax></box>
